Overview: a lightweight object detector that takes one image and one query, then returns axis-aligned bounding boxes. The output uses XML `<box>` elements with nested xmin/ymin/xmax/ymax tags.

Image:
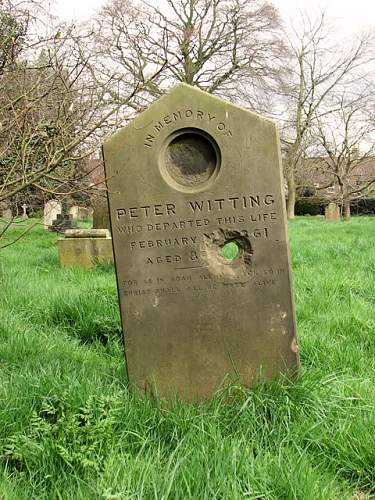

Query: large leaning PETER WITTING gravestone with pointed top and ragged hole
<box><xmin>104</xmin><ymin>84</ymin><xmax>298</xmax><ymax>401</ymax></box>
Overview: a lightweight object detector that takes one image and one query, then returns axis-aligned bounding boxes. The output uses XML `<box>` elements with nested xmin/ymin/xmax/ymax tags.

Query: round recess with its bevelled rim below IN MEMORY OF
<box><xmin>160</xmin><ymin>128</ymin><xmax>221</xmax><ymax>192</ymax></box>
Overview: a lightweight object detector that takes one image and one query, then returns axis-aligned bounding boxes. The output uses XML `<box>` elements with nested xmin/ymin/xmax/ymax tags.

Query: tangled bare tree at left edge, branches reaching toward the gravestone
<box><xmin>0</xmin><ymin>0</ymin><xmax>167</xmax><ymax>247</ymax></box>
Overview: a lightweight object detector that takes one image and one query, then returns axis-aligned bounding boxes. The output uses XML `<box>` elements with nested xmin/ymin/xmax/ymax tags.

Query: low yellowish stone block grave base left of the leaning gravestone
<box><xmin>58</xmin><ymin>230</ymin><xmax>113</xmax><ymax>268</ymax></box>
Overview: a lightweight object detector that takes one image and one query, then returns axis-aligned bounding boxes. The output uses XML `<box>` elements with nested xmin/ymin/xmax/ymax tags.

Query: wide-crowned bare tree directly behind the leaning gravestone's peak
<box><xmin>93</xmin><ymin>0</ymin><xmax>284</xmax><ymax>110</ymax></box>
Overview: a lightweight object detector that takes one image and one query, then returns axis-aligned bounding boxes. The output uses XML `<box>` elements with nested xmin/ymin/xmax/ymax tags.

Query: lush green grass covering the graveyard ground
<box><xmin>0</xmin><ymin>218</ymin><xmax>375</xmax><ymax>500</ymax></box>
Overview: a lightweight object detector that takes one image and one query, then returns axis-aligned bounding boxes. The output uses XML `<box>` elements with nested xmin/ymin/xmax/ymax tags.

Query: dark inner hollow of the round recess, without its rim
<box><xmin>164</xmin><ymin>132</ymin><xmax>218</xmax><ymax>187</ymax></box>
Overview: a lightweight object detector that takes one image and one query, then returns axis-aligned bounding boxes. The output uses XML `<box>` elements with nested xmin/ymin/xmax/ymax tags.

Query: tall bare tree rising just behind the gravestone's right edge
<box><xmin>283</xmin><ymin>14</ymin><xmax>374</xmax><ymax>218</ymax></box>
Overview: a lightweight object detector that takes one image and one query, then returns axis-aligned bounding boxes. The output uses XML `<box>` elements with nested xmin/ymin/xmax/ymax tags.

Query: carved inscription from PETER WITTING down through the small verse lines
<box><xmin>114</xmin><ymin>193</ymin><xmax>279</xmax><ymax>286</ymax></box>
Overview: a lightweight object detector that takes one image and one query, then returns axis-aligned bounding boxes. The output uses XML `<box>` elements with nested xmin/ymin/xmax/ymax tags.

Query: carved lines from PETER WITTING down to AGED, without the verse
<box><xmin>114</xmin><ymin>194</ymin><xmax>277</xmax><ymax>264</ymax></box>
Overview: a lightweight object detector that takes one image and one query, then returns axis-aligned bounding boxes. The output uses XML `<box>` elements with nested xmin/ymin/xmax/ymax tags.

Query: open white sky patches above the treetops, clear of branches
<box><xmin>51</xmin><ymin>0</ymin><xmax>375</xmax><ymax>34</ymax></box>
